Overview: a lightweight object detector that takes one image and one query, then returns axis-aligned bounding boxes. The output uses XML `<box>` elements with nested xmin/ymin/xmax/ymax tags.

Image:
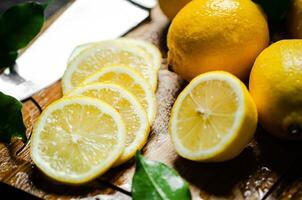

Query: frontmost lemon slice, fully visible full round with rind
<box><xmin>31</xmin><ymin>97</ymin><xmax>126</xmax><ymax>184</ymax></box>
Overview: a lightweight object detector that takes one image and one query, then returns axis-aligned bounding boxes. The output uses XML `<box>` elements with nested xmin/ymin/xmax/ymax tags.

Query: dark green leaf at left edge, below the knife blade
<box><xmin>0</xmin><ymin>92</ymin><xmax>27</xmax><ymax>143</ymax></box>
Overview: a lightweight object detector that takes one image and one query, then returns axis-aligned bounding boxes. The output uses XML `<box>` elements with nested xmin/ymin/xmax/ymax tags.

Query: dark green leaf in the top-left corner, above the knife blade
<box><xmin>0</xmin><ymin>2</ymin><xmax>48</xmax><ymax>69</ymax></box>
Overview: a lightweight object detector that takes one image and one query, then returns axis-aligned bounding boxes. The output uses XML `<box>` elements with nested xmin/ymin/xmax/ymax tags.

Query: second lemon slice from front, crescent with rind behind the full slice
<box><xmin>68</xmin><ymin>83</ymin><xmax>150</xmax><ymax>165</ymax></box>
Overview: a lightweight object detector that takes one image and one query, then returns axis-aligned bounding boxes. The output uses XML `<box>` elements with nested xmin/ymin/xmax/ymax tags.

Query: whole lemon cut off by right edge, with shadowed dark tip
<box><xmin>249</xmin><ymin>39</ymin><xmax>302</xmax><ymax>139</ymax></box>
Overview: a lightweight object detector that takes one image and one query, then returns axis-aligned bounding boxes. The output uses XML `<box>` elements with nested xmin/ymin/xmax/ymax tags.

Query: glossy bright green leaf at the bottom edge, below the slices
<box><xmin>132</xmin><ymin>153</ymin><xmax>191</xmax><ymax>200</ymax></box>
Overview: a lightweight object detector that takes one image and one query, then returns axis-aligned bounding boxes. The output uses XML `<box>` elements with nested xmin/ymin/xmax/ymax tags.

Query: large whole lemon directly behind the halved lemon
<box><xmin>167</xmin><ymin>0</ymin><xmax>269</xmax><ymax>80</ymax></box>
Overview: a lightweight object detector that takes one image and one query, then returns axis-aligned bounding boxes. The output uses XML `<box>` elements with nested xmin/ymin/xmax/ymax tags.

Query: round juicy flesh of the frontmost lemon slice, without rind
<box><xmin>38</xmin><ymin>104</ymin><xmax>118</xmax><ymax>177</ymax></box>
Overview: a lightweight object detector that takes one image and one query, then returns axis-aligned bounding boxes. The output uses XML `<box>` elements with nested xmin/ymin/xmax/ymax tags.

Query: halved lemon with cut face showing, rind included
<box><xmin>169</xmin><ymin>71</ymin><xmax>257</xmax><ymax>162</ymax></box>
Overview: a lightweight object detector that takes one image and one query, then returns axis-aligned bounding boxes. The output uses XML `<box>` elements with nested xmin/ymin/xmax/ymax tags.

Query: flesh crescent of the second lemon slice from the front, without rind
<box><xmin>73</xmin><ymin>88</ymin><xmax>141</xmax><ymax>153</ymax></box>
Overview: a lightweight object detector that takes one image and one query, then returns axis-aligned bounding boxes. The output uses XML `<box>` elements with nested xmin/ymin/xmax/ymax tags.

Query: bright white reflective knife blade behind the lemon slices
<box><xmin>0</xmin><ymin>0</ymin><xmax>156</xmax><ymax>100</ymax></box>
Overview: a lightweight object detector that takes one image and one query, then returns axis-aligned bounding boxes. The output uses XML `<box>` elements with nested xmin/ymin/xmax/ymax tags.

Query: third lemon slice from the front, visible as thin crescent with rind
<box><xmin>82</xmin><ymin>66</ymin><xmax>156</xmax><ymax>124</ymax></box>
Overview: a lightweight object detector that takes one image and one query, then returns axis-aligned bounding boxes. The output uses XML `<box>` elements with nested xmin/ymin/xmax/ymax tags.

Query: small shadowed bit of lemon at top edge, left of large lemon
<box><xmin>158</xmin><ymin>0</ymin><xmax>191</xmax><ymax>20</ymax></box>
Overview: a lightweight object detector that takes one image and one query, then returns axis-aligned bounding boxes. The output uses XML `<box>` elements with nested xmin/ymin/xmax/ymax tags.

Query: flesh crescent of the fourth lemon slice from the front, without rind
<box><xmin>70</xmin><ymin>46</ymin><xmax>156</xmax><ymax>92</ymax></box>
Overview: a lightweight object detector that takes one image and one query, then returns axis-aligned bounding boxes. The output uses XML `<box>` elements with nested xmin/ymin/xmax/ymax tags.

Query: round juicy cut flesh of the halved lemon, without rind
<box><xmin>177</xmin><ymin>80</ymin><xmax>238</xmax><ymax>152</ymax></box>
